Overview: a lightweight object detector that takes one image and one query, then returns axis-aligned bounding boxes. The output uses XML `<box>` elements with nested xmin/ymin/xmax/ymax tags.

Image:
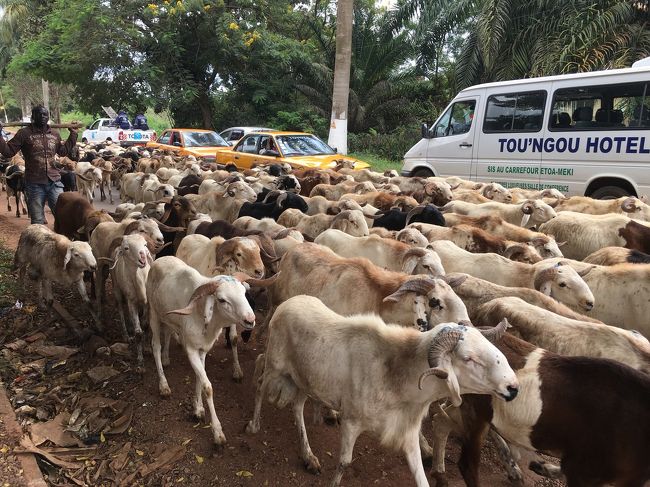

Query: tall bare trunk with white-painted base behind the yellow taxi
<box><xmin>327</xmin><ymin>0</ymin><xmax>353</xmax><ymax>154</ymax></box>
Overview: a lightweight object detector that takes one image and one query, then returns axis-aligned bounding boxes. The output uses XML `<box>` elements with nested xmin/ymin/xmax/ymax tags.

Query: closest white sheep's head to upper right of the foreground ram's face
<box><xmin>535</xmin><ymin>262</ymin><xmax>594</xmax><ymax>311</ymax></box>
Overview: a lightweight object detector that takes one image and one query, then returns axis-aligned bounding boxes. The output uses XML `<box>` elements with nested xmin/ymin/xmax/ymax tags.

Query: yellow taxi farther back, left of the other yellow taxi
<box><xmin>147</xmin><ymin>129</ymin><xmax>230</xmax><ymax>162</ymax></box>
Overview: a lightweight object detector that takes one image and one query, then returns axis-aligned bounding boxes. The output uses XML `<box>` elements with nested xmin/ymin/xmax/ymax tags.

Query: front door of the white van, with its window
<box><xmin>427</xmin><ymin>96</ymin><xmax>480</xmax><ymax>179</ymax></box>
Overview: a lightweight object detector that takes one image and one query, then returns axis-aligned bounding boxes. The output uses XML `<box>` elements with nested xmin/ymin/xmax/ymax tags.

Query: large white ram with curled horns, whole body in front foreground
<box><xmin>246</xmin><ymin>296</ymin><xmax>519</xmax><ymax>487</ymax></box>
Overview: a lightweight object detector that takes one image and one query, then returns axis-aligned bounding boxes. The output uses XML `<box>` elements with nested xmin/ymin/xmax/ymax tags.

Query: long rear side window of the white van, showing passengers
<box><xmin>549</xmin><ymin>81</ymin><xmax>650</xmax><ymax>131</ymax></box>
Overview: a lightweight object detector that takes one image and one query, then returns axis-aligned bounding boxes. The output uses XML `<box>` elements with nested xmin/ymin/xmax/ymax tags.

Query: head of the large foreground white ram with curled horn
<box><xmin>431</xmin><ymin>323</ymin><xmax>519</xmax><ymax>406</ymax></box>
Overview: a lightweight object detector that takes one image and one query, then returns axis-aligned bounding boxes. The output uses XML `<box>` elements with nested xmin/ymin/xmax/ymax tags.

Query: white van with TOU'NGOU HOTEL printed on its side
<box><xmin>402</xmin><ymin>66</ymin><xmax>650</xmax><ymax>198</ymax></box>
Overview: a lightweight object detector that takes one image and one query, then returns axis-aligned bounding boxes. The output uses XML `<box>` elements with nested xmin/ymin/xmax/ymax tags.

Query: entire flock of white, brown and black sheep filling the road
<box><xmin>7</xmin><ymin>145</ymin><xmax>650</xmax><ymax>487</ymax></box>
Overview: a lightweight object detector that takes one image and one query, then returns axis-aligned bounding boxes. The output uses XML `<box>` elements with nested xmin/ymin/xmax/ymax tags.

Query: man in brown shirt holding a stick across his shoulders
<box><xmin>0</xmin><ymin>105</ymin><xmax>77</xmax><ymax>223</ymax></box>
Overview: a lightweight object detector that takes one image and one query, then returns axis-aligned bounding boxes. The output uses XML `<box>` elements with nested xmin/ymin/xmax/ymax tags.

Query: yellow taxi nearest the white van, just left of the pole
<box><xmin>217</xmin><ymin>131</ymin><xmax>370</xmax><ymax>169</ymax></box>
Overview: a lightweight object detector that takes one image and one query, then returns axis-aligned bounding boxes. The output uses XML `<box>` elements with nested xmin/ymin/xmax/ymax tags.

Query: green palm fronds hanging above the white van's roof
<box><xmin>393</xmin><ymin>0</ymin><xmax>650</xmax><ymax>88</ymax></box>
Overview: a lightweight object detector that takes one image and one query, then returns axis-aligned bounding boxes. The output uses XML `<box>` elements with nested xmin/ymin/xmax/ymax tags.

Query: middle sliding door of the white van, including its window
<box><xmin>472</xmin><ymin>90</ymin><xmax>547</xmax><ymax>189</ymax></box>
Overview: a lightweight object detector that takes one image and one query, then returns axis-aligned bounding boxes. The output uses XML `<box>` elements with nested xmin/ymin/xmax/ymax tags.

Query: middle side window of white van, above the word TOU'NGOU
<box><xmin>483</xmin><ymin>91</ymin><xmax>546</xmax><ymax>134</ymax></box>
